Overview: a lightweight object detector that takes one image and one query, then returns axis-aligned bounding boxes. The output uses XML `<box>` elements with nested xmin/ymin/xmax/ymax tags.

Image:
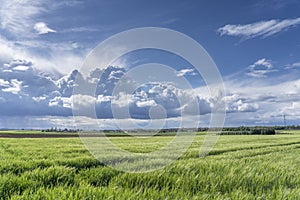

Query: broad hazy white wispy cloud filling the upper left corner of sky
<box><xmin>0</xmin><ymin>0</ymin><xmax>86</xmax><ymax>73</ymax></box>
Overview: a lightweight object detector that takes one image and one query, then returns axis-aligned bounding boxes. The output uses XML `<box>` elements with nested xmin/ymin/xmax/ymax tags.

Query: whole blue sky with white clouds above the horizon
<box><xmin>0</xmin><ymin>0</ymin><xmax>300</xmax><ymax>129</ymax></box>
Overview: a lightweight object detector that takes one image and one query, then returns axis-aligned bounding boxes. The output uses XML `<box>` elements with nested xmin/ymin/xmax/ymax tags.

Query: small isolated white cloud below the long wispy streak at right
<box><xmin>247</xmin><ymin>58</ymin><xmax>276</xmax><ymax>78</ymax></box>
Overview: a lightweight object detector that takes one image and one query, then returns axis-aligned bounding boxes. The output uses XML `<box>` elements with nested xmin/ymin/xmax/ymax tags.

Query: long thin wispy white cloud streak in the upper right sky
<box><xmin>218</xmin><ymin>17</ymin><xmax>300</xmax><ymax>39</ymax></box>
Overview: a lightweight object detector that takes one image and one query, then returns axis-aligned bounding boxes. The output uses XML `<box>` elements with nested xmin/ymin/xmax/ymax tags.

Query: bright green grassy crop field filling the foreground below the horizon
<box><xmin>0</xmin><ymin>132</ymin><xmax>300</xmax><ymax>199</ymax></box>
